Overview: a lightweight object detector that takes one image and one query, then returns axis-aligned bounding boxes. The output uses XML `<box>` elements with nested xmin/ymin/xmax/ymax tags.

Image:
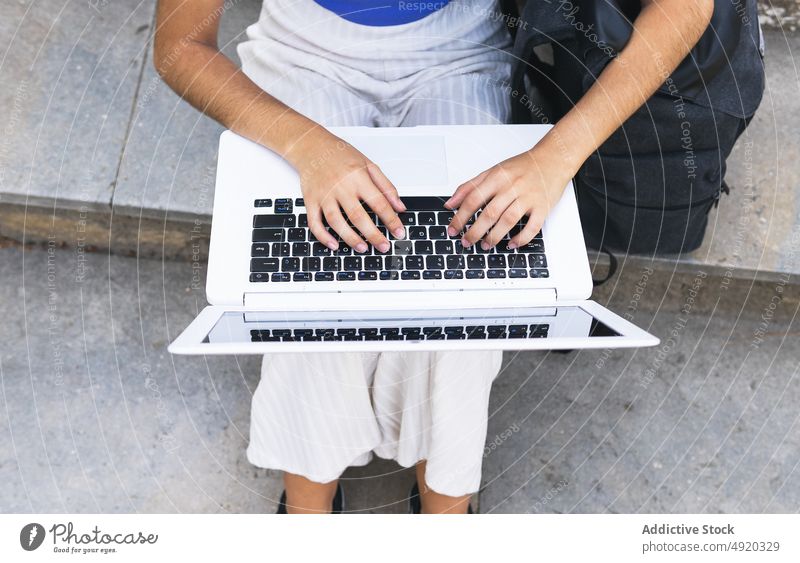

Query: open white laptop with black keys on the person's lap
<box><xmin>169</xmin><ymin>125</ymin><xmax>659</xmax><ymax>354</ymax></box>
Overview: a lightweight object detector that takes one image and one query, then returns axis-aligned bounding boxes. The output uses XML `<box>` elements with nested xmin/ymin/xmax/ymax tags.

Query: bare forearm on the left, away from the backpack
<box><xmin>155</xmin><ymin>37</ymin><xmax>327</xmax><ymax>163</ymax></box>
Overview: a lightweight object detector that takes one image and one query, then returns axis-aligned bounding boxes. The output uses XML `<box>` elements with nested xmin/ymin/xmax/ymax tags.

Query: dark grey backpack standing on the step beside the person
<box><xmin>505</xmin><ymin>0</ymin><xmax>764</xmax><ymax>260</ymax></box>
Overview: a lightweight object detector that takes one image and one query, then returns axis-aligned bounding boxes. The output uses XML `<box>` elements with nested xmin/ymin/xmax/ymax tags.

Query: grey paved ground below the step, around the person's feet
<box><xmin>0</xmin><ymin>247</ymin><xmax>800</xmax><ymax>512</ymax></box>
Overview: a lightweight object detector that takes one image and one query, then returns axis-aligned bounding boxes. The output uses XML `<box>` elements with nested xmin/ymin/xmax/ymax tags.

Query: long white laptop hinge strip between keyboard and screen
<box><xmin>244</xmin><ymin>288</ymin><xmax>558</xmax><ymax>311</ymax></box>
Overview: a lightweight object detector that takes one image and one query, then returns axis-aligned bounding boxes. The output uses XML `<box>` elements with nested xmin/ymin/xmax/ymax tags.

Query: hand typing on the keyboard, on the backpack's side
<box><xmin>445</xmin><ymin>147</ymin><xmax>573</xmax><ymax>249</ymax></box>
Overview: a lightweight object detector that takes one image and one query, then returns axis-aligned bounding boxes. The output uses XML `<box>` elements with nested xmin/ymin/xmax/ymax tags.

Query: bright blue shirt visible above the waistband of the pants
<box><xmin>315</xmin><ymin>0</ymin><xmax>450</xmax><ymax>26</ymax></box>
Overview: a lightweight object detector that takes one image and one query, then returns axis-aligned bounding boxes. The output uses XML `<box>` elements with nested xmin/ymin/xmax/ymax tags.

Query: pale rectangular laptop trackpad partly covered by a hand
<box><xmin>348</xmin><ymin>135</ymin><xmax>447</xmax><ymax>187</ymax></box>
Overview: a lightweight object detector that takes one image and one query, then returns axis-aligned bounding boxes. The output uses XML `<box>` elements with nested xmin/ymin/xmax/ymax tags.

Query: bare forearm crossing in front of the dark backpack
<box><xmin>539</xmin><ymin>0</ymin><xmax>713</xmax><ymax>174</ymax></box>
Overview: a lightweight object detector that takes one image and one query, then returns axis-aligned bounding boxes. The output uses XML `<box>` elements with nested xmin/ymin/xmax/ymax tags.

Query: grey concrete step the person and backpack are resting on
<box><xmin>0</xmin><ymin>0</ymin><xmax>800</xmax><ymax>278</ymax></box>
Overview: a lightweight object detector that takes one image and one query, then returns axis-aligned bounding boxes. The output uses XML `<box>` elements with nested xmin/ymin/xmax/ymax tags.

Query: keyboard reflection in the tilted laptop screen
<box><xmin>250</xmin><ymin>324</ymin><xmax>550</xmax><ymax>342</ymax></box>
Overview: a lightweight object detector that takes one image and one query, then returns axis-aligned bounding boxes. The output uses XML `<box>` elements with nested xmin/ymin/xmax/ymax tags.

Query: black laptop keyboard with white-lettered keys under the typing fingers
<box><xmin>250</xmin><ymin>197</ymin><xmax>549</xmax><ymax>283</ymax></box>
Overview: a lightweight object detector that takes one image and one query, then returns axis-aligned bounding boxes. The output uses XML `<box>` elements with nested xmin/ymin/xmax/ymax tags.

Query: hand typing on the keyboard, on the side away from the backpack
<box><xmin>289</xmin><ymin>130</ymin><xmax>405</xmax><ymax>252</ymax></box>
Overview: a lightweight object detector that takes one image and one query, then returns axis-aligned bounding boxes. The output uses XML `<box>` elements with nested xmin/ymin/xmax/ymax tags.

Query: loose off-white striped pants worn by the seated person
<box><xmin>238</xmin><ymin>0</ymin><xmax>511</xmax><ymax>496</ymax></box>
